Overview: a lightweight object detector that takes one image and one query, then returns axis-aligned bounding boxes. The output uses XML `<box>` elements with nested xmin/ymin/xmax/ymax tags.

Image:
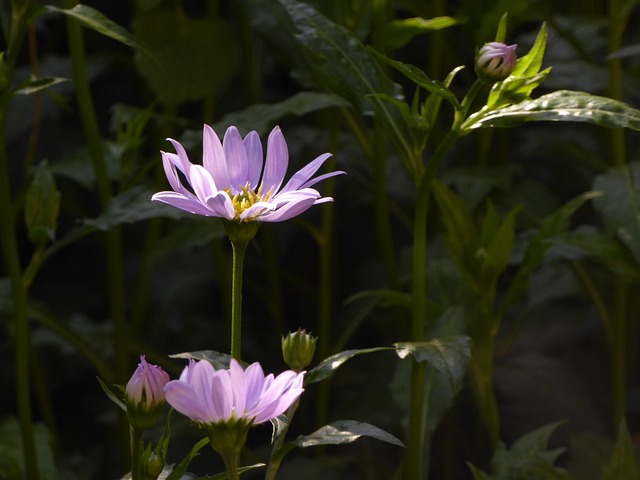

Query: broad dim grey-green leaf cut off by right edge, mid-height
<box><xmin>594</xmin><ymin>163</ymin><xmax>640</xmax><ymax>265</ymax></box>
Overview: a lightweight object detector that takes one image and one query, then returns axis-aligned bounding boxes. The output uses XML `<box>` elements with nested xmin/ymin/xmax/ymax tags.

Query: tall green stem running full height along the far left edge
<box><xmin>0</xmin><ymin>1</ymin><xmax>38</xmax><ymax>480</ymax></box>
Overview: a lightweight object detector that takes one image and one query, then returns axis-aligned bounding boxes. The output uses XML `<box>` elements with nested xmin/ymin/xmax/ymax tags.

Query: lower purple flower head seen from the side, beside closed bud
<box><xmin>164</xmin><ymin>359</ymin><xmax>304</xmax><ymax>426</ymax></box>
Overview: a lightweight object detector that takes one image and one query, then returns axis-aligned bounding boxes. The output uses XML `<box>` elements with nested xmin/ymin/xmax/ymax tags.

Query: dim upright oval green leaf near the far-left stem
<box><xmin>24</xmin><ymin>161</ymin><xmax>60</xmax><ymax>244</ymax></box>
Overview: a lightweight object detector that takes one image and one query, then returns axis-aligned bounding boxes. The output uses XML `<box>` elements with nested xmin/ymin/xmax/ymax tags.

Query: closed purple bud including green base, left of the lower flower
<box><xmin>125</xmin><ymin>355</ymin><xmax>170</xmax><ymax>428</ymax></box>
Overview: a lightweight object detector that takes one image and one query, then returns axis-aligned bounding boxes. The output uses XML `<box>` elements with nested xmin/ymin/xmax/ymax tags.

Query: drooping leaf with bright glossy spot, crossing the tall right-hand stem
<box><xmin>394</xmin><ymin>335</ymin><xmax>471</xmax><ymax>391</ymax></box>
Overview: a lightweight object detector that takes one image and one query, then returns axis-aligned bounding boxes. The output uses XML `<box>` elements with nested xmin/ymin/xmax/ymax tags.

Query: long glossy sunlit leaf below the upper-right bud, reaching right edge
<box><xmin>463</xmin><ymin>90</ymin><xmax>640</xmax><ymax>130</ymax></box>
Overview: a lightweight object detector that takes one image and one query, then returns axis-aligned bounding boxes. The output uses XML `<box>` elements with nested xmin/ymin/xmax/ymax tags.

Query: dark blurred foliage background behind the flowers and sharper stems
<box><xmin>0</xmin><ymin>0</ymin><xmax>640</xmax><ymax>480</ymax></box>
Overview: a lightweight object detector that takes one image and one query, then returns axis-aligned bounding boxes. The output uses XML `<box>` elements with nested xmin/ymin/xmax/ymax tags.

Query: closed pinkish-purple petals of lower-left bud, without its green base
<box><xmin>125</xmin><ymin>355</ymin><xmax>170</xmax><ymax>410</ymax></box>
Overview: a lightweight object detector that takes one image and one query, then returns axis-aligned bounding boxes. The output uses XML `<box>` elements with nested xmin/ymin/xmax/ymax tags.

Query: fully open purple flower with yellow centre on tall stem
<box><xmin>151</xmin><ymin>125</ymin><xmax>344</xmax><ymax>222</ymax></box>
